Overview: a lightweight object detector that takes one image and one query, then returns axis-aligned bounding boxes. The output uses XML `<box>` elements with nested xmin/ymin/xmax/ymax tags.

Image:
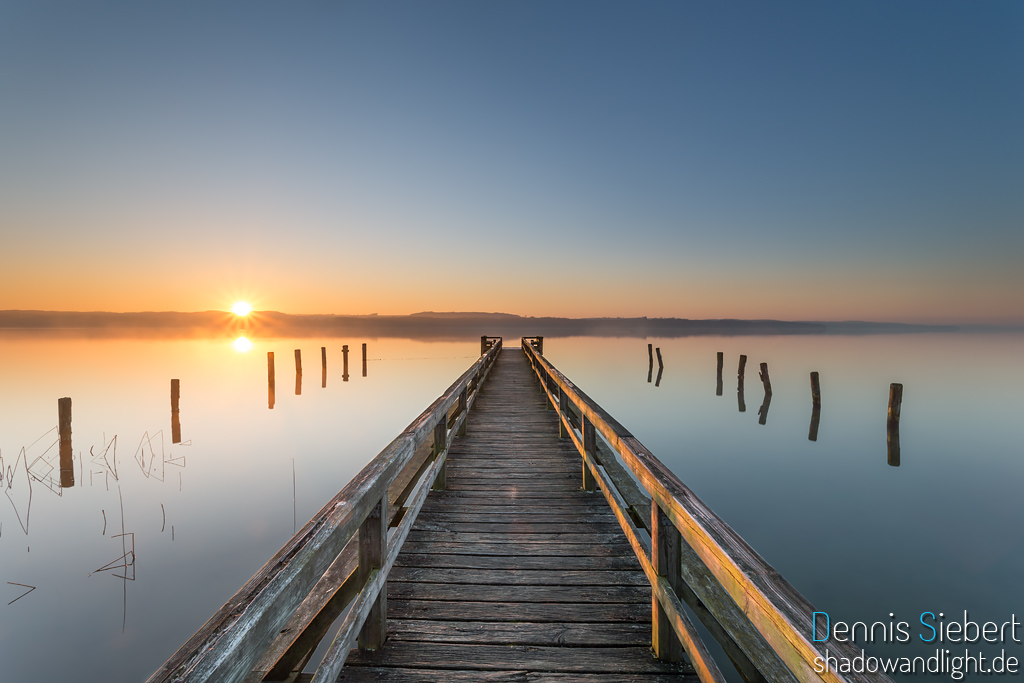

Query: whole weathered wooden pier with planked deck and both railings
<box><xmin>150</xmin><ymin>337</ymin><xmax>889</xmax><ymax>683</ymax></box>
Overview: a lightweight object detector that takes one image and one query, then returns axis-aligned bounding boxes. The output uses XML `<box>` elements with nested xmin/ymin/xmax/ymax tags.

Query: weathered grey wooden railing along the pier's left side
<box><xmin>150</xmin><ymin>337</ymin><xmax>502</xmax><ymax>683</ymax></box>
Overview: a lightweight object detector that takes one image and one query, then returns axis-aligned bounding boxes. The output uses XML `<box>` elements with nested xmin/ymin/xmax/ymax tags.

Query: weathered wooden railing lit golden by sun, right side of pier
<box><xmin>522</xmin><ymin>337</ymin><xmax>890</xmax><ymax>683</ymax></box>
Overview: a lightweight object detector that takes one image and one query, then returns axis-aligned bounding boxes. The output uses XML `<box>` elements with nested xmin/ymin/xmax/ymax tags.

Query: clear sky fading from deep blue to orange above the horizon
<box><xmin>0</xmin><ymin>0</ymin><xmax>1024</xmax><ymax>324</ymax></box>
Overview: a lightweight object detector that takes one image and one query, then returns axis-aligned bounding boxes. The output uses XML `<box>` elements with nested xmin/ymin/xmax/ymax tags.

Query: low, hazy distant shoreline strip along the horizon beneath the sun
<box><xmin>0</xmin><ymin>310</ymin><xmax>987</xmax><ymax>340</ymax></box>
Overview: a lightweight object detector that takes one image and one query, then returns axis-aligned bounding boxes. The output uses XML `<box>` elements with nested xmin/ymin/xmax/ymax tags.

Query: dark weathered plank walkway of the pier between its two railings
<box><xmin>339</xmin><ymin>349</ymin><xmax>697</xmax><ymax>683</ymax></box>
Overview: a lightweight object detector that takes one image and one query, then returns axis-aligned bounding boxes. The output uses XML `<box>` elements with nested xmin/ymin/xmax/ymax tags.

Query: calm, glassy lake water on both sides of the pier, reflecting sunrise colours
<box><xmin>0</xmin><ymin>334</ymin><xmax>1024</xmax><ymax>681</ymax></box>
